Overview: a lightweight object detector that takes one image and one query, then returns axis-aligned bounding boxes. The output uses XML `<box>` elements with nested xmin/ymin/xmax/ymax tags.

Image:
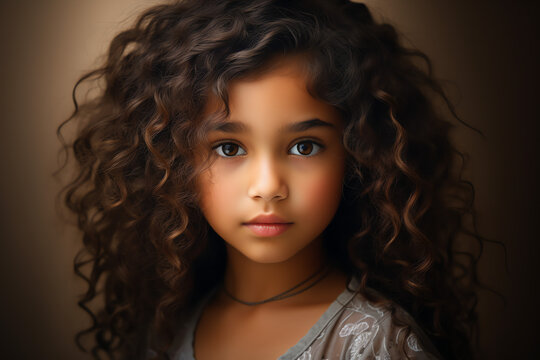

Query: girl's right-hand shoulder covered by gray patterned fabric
<box><xmin>310</xmin><ymin>293</ymin><xmax>440</xmax><ymax>360</ymax></box>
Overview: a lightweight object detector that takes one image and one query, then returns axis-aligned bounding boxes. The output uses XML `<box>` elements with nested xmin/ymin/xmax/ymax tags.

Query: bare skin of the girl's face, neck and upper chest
<box><xmin>195</xmin><ymin>58</ymin><xmax>346</xmax><ymax>360</ymax></box>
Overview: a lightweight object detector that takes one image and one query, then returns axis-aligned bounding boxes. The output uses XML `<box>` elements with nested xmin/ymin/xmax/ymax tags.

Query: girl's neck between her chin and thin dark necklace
<box><xmin>221</xmin><ymin>239</ymin><xmax>326</xmax><ymax>302</ymax></box>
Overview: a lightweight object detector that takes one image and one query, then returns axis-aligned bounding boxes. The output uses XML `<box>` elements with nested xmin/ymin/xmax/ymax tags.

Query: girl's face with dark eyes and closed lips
<box><xmin>199</xmin><ymin>59</ymin><xmax>345</xmax><ymax>263</ymax></box>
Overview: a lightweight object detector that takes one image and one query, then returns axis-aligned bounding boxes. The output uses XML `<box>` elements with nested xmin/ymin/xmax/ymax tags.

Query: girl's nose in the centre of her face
<box><xmin>248</xmin><ymin>156</ymin><xmax>289</xmax><ymax>202</ymax></box>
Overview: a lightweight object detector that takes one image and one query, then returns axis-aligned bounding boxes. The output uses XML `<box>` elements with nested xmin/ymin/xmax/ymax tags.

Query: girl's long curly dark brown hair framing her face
<box><xmin>58</xmin><ymin>0</ymin><xmax>482</xmax><ymax>359</ymax></box>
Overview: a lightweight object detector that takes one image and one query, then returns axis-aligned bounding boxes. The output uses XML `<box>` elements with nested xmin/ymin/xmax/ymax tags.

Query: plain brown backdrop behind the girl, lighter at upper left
<box><xmin>0</xmin><ymin>0</ymin><xmax>540</xmax><ymax>359</ymax></box>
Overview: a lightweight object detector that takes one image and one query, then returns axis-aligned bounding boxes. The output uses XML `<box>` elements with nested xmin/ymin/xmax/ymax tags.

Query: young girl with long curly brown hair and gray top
<box><xmin>59</xmin><ymin>0</ymin><xmax>481</xmax><ymax>360</ymax></box>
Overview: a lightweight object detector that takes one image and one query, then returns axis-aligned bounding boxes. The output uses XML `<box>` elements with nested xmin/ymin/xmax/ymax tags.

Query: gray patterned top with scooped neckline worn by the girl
<box><xmin>169</xmin><ymin>279</ymin><xmax>440</xmax><ymax>360</ymax></box>
